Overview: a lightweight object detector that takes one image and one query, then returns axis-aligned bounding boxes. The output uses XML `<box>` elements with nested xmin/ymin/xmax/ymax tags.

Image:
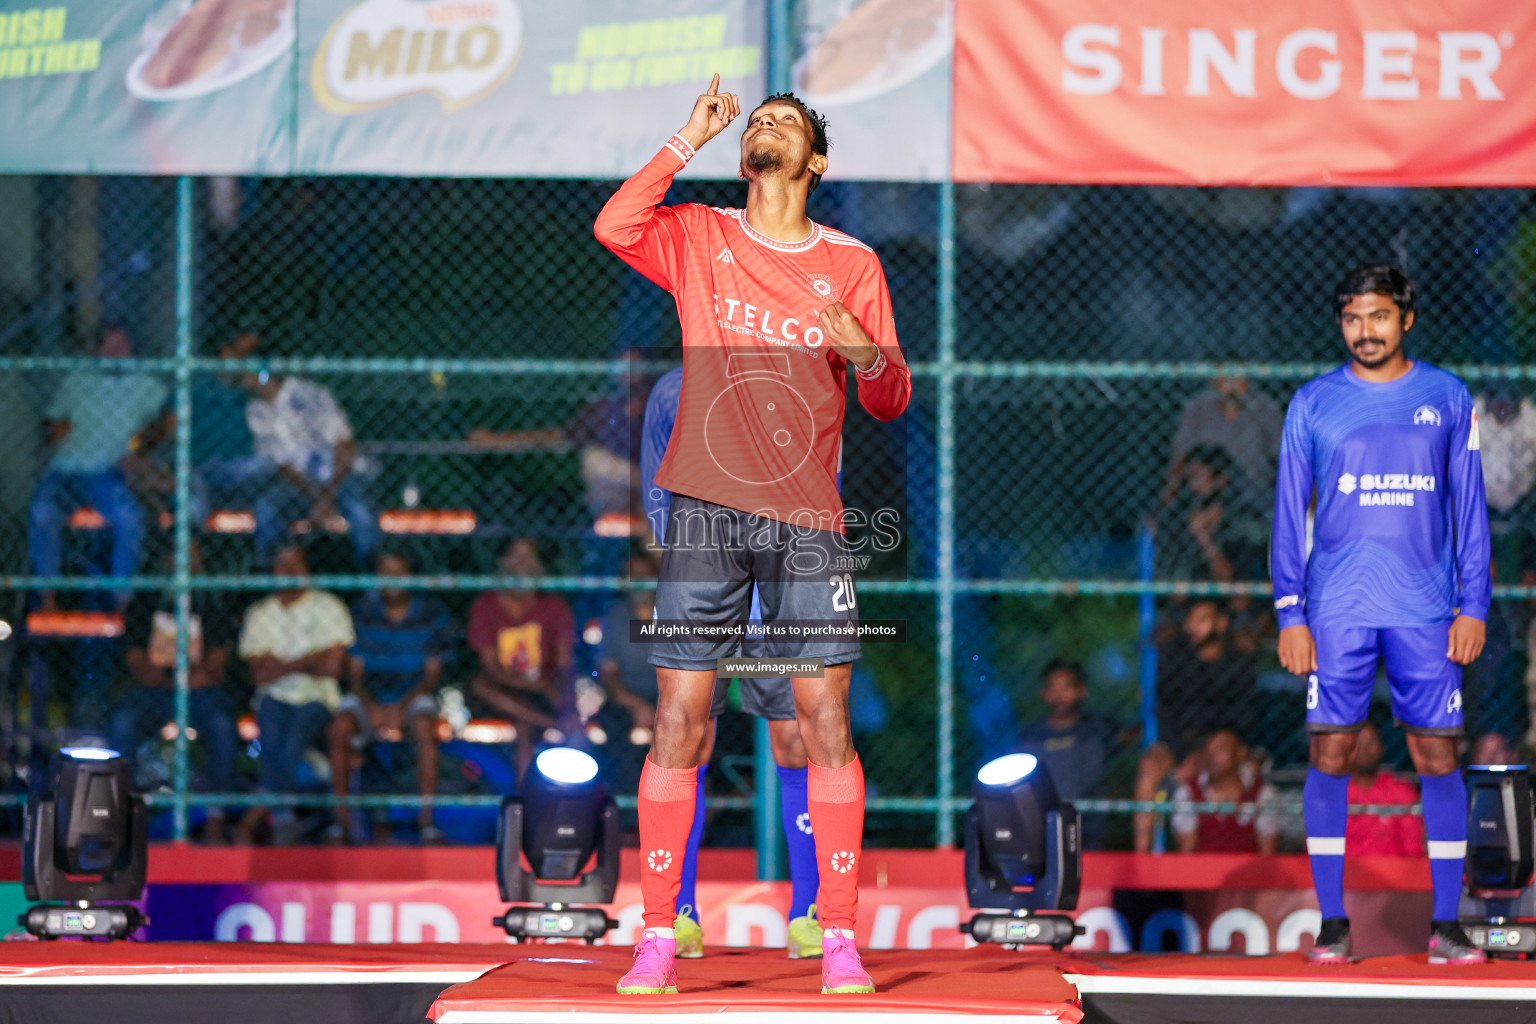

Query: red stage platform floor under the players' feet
<box><xmin>0</xmin><ymin>941</ymin><xmax>1536</xmax><ymax>1024</ymax></box>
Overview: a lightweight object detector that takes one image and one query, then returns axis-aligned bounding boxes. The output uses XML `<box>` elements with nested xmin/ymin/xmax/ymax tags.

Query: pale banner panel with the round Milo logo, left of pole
<box><xmin>295</xmin><ymin>0</ymin><xmax>766</xmax><ymax>178</ymax></box>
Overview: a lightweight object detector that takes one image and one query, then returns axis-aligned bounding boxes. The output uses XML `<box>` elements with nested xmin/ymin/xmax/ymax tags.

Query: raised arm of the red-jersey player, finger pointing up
<box><xmin>593</xmin><ymin>75</ymin><xmax>742</xmax><ymax>292</ymax></box>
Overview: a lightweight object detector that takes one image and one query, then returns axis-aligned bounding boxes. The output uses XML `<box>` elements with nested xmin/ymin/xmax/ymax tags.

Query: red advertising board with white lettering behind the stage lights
<box><xmin>0</xmin><ymin>846</ymin><xmax>1430</xmax><ymax>956</ymax></box>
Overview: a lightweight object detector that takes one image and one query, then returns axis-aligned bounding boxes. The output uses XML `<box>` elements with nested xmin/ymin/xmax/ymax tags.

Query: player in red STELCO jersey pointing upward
<box><xmin>596</xmin><ymin>75</ymin><xmax>912</xmax><ymax>993</ymax></box>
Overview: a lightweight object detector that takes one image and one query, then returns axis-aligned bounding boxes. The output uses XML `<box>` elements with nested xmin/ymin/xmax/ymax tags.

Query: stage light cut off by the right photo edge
<box><xmin>1458</xmin><ymin>765</ymin><xmax>1536</xmax><ymax>955</ymax></box>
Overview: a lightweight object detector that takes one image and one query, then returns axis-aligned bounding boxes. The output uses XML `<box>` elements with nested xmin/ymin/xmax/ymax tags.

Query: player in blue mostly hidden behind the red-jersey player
<box><xmin>641</xmin><ymin>367</ymin><xmax>842</xmax><ymax>960</ymax></box>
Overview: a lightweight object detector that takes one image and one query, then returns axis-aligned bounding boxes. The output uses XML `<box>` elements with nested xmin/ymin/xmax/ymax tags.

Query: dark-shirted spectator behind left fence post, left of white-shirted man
<box><xmin>108</xmin><ymin>542</ymin><xmax>240</xmax><ymax>843</ymax></box>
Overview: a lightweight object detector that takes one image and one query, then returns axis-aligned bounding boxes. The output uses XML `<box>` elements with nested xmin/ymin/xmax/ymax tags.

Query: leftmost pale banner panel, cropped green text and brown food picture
<box><xmin>0</xmin><ymin>0</ymin><xmax>295</xmax><ymax>173</ymax></box>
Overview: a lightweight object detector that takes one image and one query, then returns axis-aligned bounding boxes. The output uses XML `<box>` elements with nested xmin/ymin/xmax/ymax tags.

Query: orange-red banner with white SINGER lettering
<box><xmin>954</xmin><ymin>0</ymin><xmax>1536</xmax><ymax>186</ymax></box>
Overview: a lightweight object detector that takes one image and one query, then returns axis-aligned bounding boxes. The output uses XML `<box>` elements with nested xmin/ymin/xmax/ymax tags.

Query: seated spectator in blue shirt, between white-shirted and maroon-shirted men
<box><xmin>327</xmin><ymin>553</ymin><xmax>450</xmax><ymax>844</ymax></box>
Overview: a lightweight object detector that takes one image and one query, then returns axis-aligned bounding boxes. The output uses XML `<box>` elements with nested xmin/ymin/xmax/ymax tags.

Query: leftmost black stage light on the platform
<box><xmin>20</xmin><ymin>746</ymin><xmax>149</xmax><ymax>938</ymax></box>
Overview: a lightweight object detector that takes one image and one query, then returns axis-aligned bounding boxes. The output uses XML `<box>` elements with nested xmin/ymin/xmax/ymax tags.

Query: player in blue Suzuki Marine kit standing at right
<box><xmin>1270</xmin><ymin>264</ymin><xmax>1491</xmax><ymax>964</ymax></box>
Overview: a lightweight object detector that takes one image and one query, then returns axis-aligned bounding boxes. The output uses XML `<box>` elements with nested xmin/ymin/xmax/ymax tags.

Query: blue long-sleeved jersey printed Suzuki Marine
<box><xmin>1270</xmin><ymin>362</ymin><xmax>1491</xmax><ymax>628</ymax></box>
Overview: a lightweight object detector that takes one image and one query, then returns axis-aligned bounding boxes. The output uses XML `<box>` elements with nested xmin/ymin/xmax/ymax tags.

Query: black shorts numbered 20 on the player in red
<box><xmin>650</xmin><ymin>494</ymin><xmax>860</xmax><ymax>671</ymax></box>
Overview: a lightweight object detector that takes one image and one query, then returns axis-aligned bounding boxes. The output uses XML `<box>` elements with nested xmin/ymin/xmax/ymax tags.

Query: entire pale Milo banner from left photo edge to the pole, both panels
<box><xmin>0</xmin><ymin>0</ymin><xmax>766</xmax><ymax>177</ymax></box>
